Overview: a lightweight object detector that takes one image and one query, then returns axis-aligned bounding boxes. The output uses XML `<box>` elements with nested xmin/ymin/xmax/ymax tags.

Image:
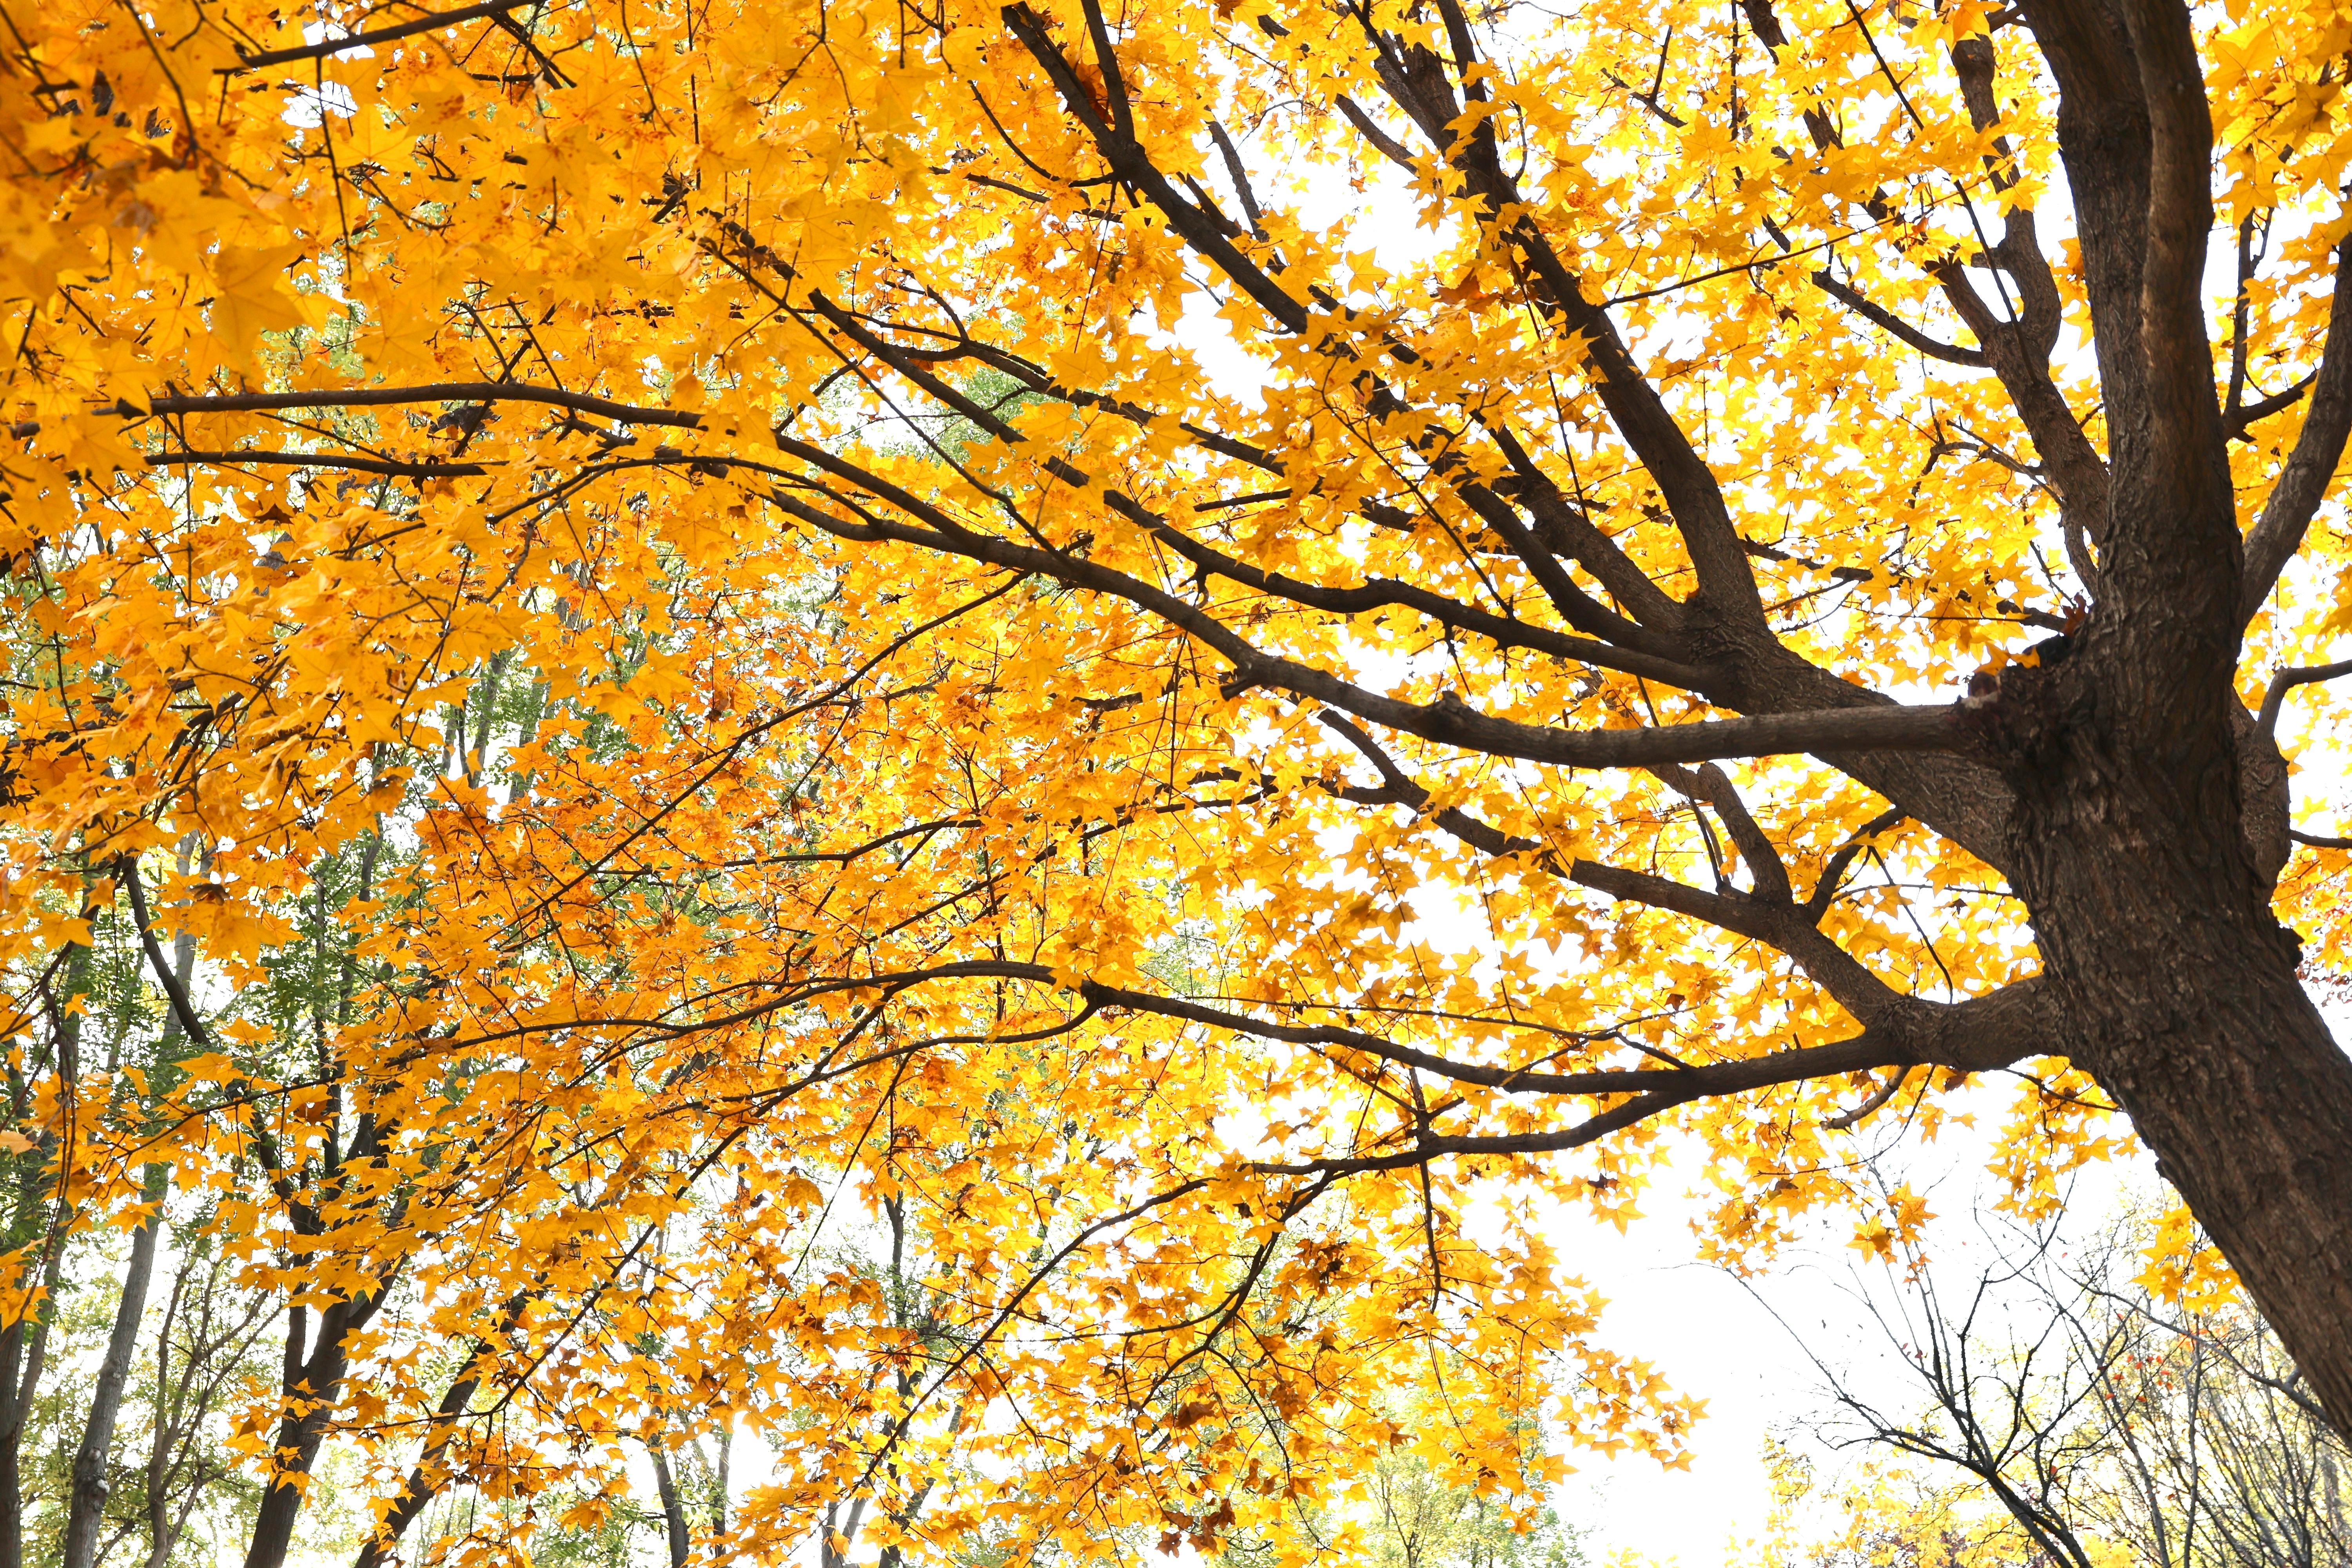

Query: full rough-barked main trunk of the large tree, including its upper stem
<box><xmin>1985</xmin><ymin>0</ymin><xmax>2352</xmax><ymax>1432</ymax></box>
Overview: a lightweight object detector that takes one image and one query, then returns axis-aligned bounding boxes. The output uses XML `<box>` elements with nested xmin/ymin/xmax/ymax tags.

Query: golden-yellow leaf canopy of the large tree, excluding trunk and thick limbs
<box><xmin>0</xmin><ymin>0</ymin><xmax>2352</xmax><ymax>1561</ymax></box>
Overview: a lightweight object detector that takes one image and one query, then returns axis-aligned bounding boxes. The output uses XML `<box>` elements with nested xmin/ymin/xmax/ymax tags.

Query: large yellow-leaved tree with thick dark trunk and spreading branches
<box><xmin>0</xmin><ymin>0</ymin><xmax>2352</xmax><ymax>1568</ymax></box>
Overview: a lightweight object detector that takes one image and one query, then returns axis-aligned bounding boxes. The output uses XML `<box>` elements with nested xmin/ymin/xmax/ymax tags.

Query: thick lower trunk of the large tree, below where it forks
<box><xmin>2002</xmin><ymin>665</ymin><xmax>2352</xmax><ymax>1432</ymax></box>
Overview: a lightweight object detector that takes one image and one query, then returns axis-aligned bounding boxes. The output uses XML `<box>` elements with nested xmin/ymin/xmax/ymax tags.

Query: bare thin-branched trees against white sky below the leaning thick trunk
<box><xmin>1759</xmin><ymin>1194</ymin><xmax>2352</xmax><ymax>1568</ymax></box>
